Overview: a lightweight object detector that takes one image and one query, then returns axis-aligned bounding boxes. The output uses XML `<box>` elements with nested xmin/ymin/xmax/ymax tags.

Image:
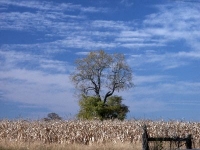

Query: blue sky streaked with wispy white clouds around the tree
<box><xmin>0</xmin><ymin>0</ymin><xmax>200</xmax><ymax>121</ymax></box>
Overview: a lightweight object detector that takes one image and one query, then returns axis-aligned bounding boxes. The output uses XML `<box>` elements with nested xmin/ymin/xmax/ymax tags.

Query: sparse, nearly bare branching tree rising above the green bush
<box><xmin>71</xmin><ymin>50</ymin><xmax>133</xmax><ymax>104</ymax></box>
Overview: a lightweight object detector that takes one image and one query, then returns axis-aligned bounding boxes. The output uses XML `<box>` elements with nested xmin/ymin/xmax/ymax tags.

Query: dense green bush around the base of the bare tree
<box><xmin>78</xmin><ymin>95</ymin><xmax>129</xmax><ymax>120</ymax></box>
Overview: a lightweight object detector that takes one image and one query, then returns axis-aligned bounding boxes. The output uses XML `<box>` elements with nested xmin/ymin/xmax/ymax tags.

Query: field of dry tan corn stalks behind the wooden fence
<box><xmin>0</xmin><ymin>120</ymin><xmax>200</xmax><ymax>150</ymax></box>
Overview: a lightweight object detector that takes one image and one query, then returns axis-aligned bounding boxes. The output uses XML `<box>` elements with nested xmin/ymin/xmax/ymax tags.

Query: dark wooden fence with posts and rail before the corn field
<box><xmin>142</xmin><ymin>125</ymin><xmax>192</xmax><ymax>150</ymax></box>
